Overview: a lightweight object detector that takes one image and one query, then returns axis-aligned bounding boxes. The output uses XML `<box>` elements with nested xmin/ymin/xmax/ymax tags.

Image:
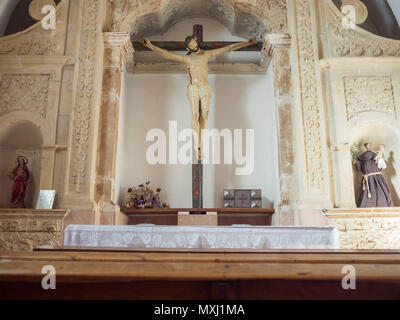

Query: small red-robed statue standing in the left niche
<box><xmin>9</xmin><ymin>156</ymin><xmax>30</xmax><ymax>208</ymax></box>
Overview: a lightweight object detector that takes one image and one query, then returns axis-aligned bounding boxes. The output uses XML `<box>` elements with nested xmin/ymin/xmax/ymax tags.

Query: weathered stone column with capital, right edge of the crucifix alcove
<box><xmin>264</xmin><ymin>34</ymin><xmax>297</xmax><ymax>225</ymax></box>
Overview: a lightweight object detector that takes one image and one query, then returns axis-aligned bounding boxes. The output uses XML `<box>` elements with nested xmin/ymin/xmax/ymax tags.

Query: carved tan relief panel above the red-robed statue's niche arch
<box><xmin>0</xmin><ymin>74</ymin><xmax>50</xmax><ymax>118</ymax></box>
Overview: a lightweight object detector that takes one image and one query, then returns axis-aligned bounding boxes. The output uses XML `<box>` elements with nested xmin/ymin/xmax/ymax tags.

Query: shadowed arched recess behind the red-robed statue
<box><xmin>0</xmin><ymin>121</ymin><xmax>43</xmax><ymax>208</ymax></box>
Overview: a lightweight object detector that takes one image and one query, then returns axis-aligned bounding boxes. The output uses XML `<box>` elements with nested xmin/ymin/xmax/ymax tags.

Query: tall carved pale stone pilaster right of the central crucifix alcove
<box><xmin>291</xmin><ymin>0</ymin><xmax>333</xmax><ymax>215</ymax></box>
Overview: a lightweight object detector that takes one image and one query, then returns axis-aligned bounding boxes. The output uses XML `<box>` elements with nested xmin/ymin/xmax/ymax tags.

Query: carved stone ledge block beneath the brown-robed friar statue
<box><xmin>325</xmin><ymin>208</ymin><xmax>400</xmax><ymax>249</ymax></box>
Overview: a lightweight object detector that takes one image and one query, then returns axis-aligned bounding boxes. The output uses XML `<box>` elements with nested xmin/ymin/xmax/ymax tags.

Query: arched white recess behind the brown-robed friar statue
<box><xmin>351</xmin><ymin>121</ymin><xmax>400</xmax><ymax>207</ymax></box>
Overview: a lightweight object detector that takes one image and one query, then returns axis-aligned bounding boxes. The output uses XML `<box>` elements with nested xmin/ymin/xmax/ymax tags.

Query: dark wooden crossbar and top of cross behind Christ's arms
<box><xmin>132</xmin><ymin>24</ymin><xmax>262</xmax><ymax>52</ymax></box>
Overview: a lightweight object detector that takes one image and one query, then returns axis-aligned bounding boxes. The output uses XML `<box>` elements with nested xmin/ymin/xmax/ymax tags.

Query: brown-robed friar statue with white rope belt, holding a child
<box><xmin>355</xmin><ymin>142</ymin><xmax>393</xmax><ymax>208</ymax></box>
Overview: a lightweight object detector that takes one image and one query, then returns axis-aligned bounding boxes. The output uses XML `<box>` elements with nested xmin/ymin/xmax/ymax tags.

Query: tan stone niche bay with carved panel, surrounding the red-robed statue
<box><xmin>0</xmin><ymin>56</ymin><xmax>67</xmax><ymax>208</ymax></box>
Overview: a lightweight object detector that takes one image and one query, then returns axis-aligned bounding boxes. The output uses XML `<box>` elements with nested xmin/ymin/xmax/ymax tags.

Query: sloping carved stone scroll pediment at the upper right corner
<box><xmin>326</xmin><ymin>1</ymin><xmax>400</xmax><ymax>57</ymax></box>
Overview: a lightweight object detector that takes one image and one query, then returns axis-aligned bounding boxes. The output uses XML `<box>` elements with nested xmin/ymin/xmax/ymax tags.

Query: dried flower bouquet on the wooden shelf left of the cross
<box><xmin>125</xmin><ymin>181</ymin><xmax>169</xmax><ymax>209</ymax></box>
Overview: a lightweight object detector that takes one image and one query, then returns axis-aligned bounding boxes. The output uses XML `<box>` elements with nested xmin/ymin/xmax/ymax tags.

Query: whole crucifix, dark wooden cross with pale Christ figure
<box><xmin>138</xmin><ymin>25</ymin><xmax>261</xmax><ymax>214</ymax></box>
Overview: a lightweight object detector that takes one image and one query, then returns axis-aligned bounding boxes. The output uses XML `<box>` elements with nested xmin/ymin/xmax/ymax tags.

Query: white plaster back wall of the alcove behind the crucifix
<box><xmin>117</xmin><ymin>19</ymin><xmax>279</xmax><ymax>207</ymax></box>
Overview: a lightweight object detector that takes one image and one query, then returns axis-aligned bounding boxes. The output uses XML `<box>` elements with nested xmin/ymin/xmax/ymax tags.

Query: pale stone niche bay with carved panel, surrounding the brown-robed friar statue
<box><xmin>321</xmin><ymin>57</ymin><xmax>400</xmax><ymax>208</ymax></box>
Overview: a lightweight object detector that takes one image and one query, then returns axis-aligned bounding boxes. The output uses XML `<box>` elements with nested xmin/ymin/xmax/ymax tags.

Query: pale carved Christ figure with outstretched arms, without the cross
<box><xmin>140</xmin><ymin>35</ymin><xmax>257</xmax><ymax>160</ymax></box>
